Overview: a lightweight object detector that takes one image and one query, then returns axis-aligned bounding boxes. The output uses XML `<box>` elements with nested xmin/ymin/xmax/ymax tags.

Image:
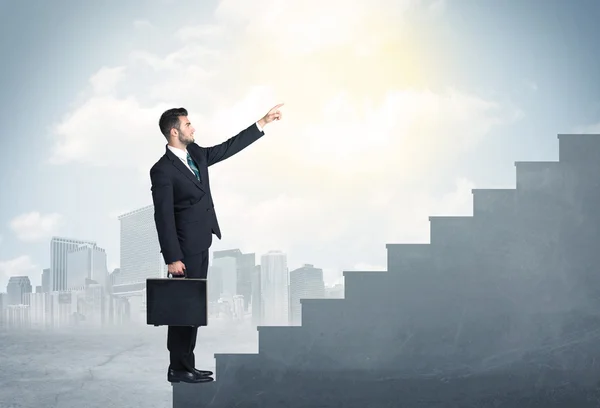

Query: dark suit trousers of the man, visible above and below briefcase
<box><xmin>167</xmin><ymin>249</ymin><xmax>209</xmax><ymax>371</ymax></box>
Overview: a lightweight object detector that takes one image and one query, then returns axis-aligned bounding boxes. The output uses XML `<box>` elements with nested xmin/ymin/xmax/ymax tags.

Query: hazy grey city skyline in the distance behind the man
<box><xmin>0</xmin><ymin>205</ymin><xmax>344</xmax><ymax>330</ymax></box>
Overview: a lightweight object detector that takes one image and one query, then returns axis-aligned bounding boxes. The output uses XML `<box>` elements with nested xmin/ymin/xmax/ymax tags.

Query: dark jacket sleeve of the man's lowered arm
<box><xmin>150</xmin><ymin>167</ymin><xmax>183</xmax><ymax>265</ymax></box>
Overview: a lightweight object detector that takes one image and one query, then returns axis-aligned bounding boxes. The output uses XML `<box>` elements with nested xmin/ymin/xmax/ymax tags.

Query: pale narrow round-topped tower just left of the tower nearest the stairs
<box><xmin>260</xmin><ymin>251</ymin><xmax>289</xmax><ymax>326</ymax></box>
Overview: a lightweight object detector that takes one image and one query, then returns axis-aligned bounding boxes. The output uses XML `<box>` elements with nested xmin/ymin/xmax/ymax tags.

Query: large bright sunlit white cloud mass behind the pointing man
<box><xmin>52</xmin><ymin>0</ymin><xmax>521</xmax><ymax>276</ymax></box>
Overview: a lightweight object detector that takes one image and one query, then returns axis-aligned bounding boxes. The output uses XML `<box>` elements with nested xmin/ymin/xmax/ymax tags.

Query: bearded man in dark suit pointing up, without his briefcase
<box><xmin>150</xmin><ymin>104</ymin><xmax>283</xmax><ymax>383</ymax></box>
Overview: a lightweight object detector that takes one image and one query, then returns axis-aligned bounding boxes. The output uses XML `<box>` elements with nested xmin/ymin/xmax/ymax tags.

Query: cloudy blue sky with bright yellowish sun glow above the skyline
<box><xmin>0</xmin><ymin>0</ymin><xmax>600</xmax><ymax>291</ymax></box>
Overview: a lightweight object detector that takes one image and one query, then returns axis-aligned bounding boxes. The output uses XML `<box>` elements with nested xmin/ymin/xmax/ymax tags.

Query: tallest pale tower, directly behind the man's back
<box><xmin>115</xmin><ymin>205</ymin><xmax>167</xmax><ymax>290</ymax></box>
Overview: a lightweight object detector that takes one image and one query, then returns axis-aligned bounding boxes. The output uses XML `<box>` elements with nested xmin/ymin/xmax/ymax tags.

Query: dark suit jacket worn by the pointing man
<box><xmin>150</xmin><ymin>124</ymin><xmax>264</xmax><ymax>264</ymax></box>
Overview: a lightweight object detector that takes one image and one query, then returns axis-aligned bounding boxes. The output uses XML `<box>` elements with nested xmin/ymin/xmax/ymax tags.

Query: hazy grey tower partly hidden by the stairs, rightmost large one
<box><xmin>290</xmin><ymin>264</ymin><xmax>325</xmax><ymax>326</ymax></box>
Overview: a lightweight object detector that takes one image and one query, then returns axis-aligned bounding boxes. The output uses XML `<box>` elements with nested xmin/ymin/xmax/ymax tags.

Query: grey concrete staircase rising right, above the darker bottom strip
<box><xmin>174</xmin><ymin>135</ymin><xmax>600</xmax><ymax>407</ymax></box>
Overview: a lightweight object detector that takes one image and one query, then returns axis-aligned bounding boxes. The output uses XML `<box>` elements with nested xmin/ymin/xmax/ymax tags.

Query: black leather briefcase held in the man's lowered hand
<box><xmin>146</xmin><ymin>274</ymin><xmax>208</xmax><ymax>327</ymax></box>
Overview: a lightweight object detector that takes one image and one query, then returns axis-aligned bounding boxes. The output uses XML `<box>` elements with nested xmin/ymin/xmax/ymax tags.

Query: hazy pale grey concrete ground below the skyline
<box><xmin>0</xmin><ymin>323</ymin><xmax>258</xmax><ymax>408</ymax></box>
